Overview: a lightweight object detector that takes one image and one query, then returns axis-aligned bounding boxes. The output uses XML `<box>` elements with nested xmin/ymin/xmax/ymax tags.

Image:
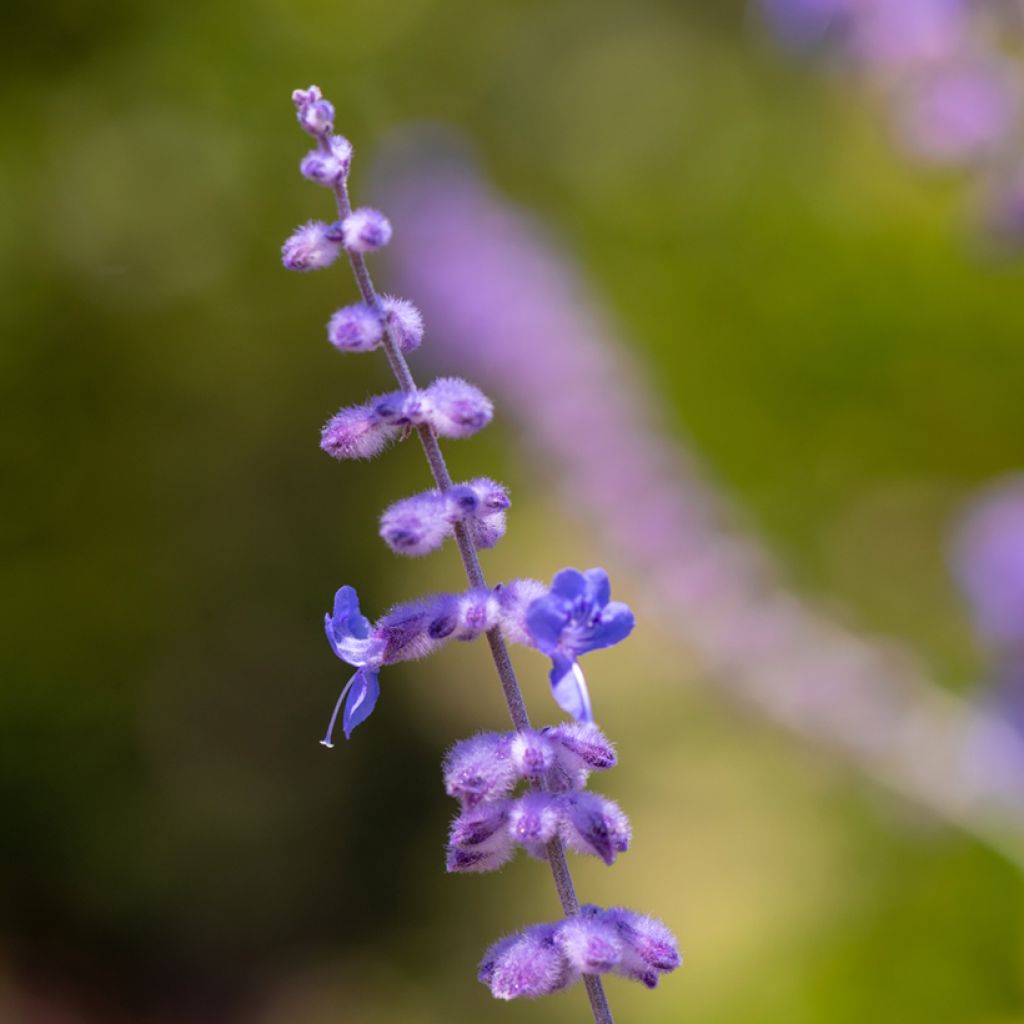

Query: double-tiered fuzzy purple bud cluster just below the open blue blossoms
<box><xmin>444</xmin><ymin>723</ymin><xmax>631</xmax><ymax>871</ymax></box>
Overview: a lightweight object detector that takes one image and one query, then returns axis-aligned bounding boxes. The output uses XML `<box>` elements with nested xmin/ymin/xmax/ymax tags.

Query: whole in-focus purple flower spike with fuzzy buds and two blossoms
<box><xmin>282</xmin><ymin>86</ymin><xmax>679</xmax><ymax>1024</ymax></box>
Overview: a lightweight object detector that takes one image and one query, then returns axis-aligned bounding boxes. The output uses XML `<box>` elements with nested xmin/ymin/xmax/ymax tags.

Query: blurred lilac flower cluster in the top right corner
<box><xmin>760</xmin><ymin>0</ymin><xmax>1024</xmax><ymax>245</ymax></box>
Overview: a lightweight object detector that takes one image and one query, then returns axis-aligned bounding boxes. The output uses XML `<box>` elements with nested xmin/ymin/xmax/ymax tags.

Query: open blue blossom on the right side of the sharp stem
<box><xmin>526</xmin><ymin>569</ymin><xmax>635</xmax><ymax>722</ymax></box>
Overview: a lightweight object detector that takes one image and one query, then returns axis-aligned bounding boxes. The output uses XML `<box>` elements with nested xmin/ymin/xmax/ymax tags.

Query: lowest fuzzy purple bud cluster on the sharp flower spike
<box><xmin>478</xmin><ymin>905</ymin><xmax>682</xmax><ymax>999</ymax></box>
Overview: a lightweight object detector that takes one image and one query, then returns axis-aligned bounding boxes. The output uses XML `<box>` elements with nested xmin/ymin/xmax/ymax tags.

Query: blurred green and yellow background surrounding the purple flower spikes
<box><xmin>6</xmin><ymin>0</ymin><xmax>1024</xmax><ymax>1024</ymax></box>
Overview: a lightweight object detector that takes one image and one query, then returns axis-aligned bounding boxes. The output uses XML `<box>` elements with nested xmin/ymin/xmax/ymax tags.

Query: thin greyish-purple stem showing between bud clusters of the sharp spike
<box><xmin>319</xmin><ymin>161</ymin><xmax>614</xmax><ymax>1024</ymax></box>
